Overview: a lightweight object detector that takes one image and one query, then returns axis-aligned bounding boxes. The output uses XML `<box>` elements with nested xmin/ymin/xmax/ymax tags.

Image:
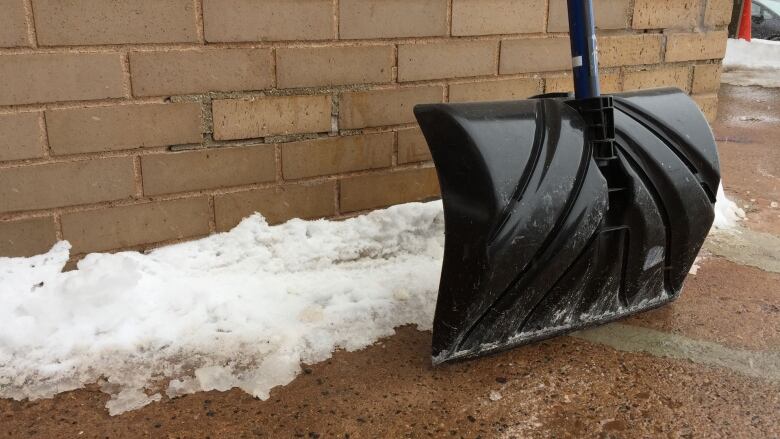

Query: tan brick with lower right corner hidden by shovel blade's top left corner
<box><xmin>339</xmin><ymin>85</ymin><xmax>444</xmax><ymax>129</ymax></box>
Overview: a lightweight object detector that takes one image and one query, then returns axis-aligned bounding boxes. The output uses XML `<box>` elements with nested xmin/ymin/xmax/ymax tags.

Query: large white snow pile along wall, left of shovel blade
<box><xmin>0</xmin><ymin>202</ymin><xmax>444</xmax><ymax>414</ymax></box>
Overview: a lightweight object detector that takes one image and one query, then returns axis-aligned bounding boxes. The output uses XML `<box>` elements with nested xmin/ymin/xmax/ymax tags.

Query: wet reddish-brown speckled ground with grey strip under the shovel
<box><xmin>0</xmin><ymin>85</ymin><xmax>780</xmax><ymax>438</ymax></box>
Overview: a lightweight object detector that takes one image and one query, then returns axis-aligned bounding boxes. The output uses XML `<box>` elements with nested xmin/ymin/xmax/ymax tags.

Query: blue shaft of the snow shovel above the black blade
<box><xmin>568</xmin><ymin>0</ymin><xmax>601</xmax><ymax>99</ymax></box>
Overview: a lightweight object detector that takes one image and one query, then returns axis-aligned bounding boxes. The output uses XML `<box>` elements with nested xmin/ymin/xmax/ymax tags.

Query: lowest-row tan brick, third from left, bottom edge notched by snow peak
<box><xmin>214</xmin><ymin>181</ymin><xmax>336</xmax><ymax>232</ymax></box>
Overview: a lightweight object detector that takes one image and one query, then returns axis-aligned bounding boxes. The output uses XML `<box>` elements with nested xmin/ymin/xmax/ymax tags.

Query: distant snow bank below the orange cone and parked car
<box><xmin>721</xmin><ymin>39</ymin><xmax>780</xmax><ymax>87</ymax></box>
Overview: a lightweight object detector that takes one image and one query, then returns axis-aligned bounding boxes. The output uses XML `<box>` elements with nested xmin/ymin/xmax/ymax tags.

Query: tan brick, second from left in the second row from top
<box><xmin>130</xmin><ymin>49</ymin><xmax>274</xmax><ymax>96</ymax></box>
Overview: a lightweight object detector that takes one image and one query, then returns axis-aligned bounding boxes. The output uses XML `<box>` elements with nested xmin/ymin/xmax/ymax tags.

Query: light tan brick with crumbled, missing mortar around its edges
<box><xmin>212</xmin><ymin>96</ymin><xmax>331</xmax><ymax>140</ymax></box>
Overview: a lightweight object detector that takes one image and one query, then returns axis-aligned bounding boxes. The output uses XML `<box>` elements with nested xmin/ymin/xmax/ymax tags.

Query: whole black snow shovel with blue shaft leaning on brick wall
<box><xmin>415</xmin><ymin>0</ymin><xmax>720</xmax><ymax>364</ymax></box>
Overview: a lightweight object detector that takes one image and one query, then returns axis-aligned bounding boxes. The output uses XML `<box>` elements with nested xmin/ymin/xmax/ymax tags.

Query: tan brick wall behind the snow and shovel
<box><xmin>0</xmin><ymin>0</ymin><xmax>732</xmax><ymax>255</ymax></box>
